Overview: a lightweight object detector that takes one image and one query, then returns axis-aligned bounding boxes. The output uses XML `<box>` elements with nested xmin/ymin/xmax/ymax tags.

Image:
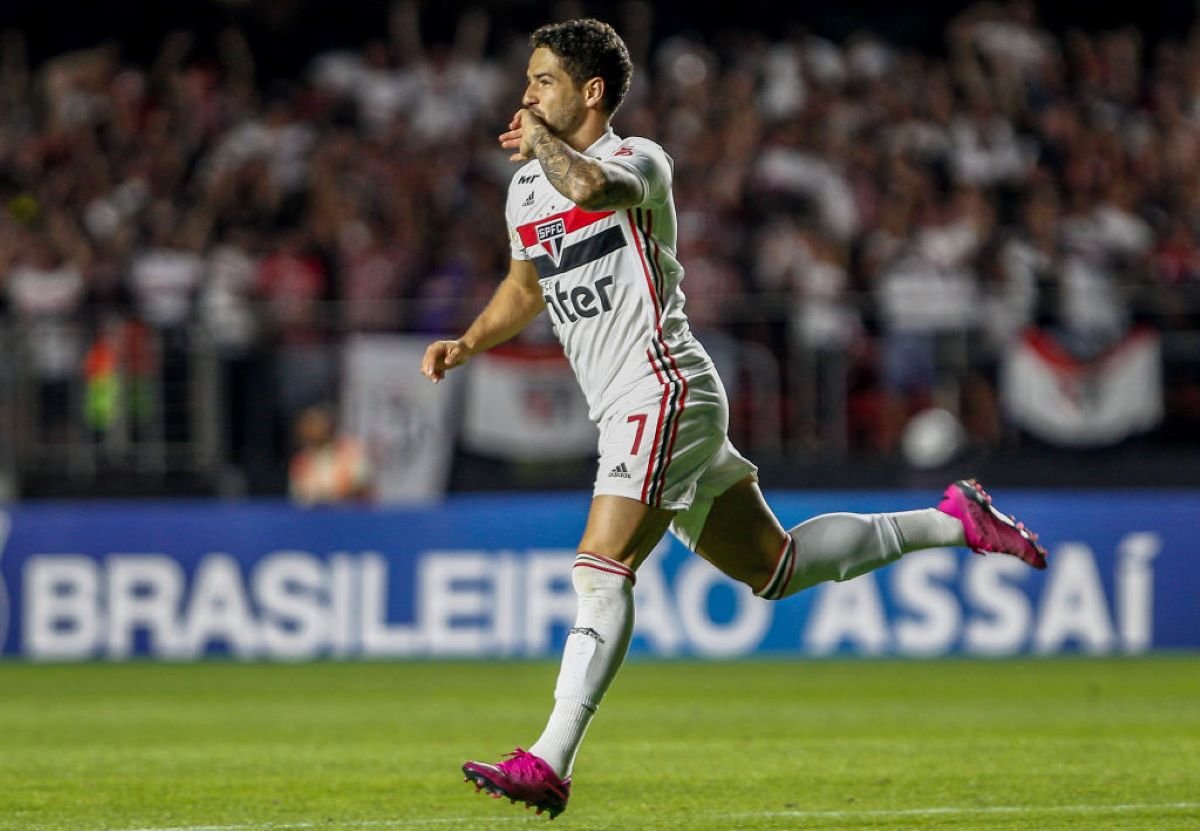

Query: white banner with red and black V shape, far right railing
<box><xmin>1001</xmin><ymin>330</ymin><xmax>1163</xmax><ymax>447</ymax></box>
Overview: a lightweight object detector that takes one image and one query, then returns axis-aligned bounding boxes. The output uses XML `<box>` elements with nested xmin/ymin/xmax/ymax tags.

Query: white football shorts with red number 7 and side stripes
<box><xmin>592</xmin><ymin>372</ymin><xmax>758</xmax><ymax>550</ymax></box>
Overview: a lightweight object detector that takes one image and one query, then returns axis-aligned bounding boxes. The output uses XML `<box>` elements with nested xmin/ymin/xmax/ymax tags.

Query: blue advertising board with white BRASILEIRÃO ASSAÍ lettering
<box><xmin>0</xmin><ymin>491</ymin><xmax>1200</xmax><ymax>660</ymax></box>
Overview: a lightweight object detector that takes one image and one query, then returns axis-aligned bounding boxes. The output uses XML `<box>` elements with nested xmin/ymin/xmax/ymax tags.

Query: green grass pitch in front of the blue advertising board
<box><xmin>0</xmin><ymin>654</ymin><xmax>1200</xmax><ymax>831</ymax></box>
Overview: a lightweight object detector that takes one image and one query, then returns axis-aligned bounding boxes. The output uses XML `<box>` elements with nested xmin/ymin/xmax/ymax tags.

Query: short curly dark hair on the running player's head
<box><xmin>529</xmin><ymin>18</ymin><xmax>634</xmax><ymax>115</ymax></box>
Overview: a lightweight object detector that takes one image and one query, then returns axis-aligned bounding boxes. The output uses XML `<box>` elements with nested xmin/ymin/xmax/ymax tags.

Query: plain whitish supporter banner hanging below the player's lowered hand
<box><xmin>342</xmin><ymin>335</ymin><xmax>462</xmax><ymax>504</ymax></box>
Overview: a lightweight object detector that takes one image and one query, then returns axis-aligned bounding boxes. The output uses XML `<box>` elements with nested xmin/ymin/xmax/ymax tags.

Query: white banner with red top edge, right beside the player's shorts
<box><xmin>462</xmin><ymin>345</ymin><xmax>596</xmax><ymax>461</ymax></box>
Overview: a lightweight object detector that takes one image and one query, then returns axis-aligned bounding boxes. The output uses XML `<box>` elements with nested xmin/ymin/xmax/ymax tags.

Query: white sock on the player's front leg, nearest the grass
<box><xmin>529</xmin><ymin>551</ymin><xmax>635</xmax><ymax>779</ymax></box>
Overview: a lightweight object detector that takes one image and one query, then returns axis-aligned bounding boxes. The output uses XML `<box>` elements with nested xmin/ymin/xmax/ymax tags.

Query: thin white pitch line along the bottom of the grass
<box><xmin>110</xmin><ymin>802</ymin><xmax>1200</xmax><ymax>831</ymax></box>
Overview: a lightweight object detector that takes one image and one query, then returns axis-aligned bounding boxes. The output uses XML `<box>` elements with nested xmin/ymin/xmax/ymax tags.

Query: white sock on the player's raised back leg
<box><xmin>757</xmin><ymin>508</ymin><xmax>964</xmax><ymax>600</ymax></box>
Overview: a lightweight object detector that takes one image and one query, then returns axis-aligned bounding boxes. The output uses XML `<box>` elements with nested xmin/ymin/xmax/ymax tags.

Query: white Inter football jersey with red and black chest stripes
<box><xmin>505</xmin><ymin>130</ymin><xmax>714</xmax><ymax>423</ymax></box>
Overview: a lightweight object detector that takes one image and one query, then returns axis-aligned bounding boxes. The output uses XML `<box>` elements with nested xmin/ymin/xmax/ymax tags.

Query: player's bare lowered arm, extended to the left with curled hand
<box><xmin>421</xmin><ymin>257</ymin><xmax>546</xmax><ymax>383</ymax></box>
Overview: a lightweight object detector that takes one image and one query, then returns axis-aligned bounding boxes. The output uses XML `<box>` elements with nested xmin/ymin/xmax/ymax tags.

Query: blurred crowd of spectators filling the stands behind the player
<box><xmin>0</xmin><ymin>0</ymin><xmax>1200</xmax><ymax>482</ymax></box>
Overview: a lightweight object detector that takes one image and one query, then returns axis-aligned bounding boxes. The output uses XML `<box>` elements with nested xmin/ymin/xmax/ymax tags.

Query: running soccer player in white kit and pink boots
<box><xmin>421</xmin><ymin>19</ymin><xmax>1045</xmax><ymax>818</ymax></box>
